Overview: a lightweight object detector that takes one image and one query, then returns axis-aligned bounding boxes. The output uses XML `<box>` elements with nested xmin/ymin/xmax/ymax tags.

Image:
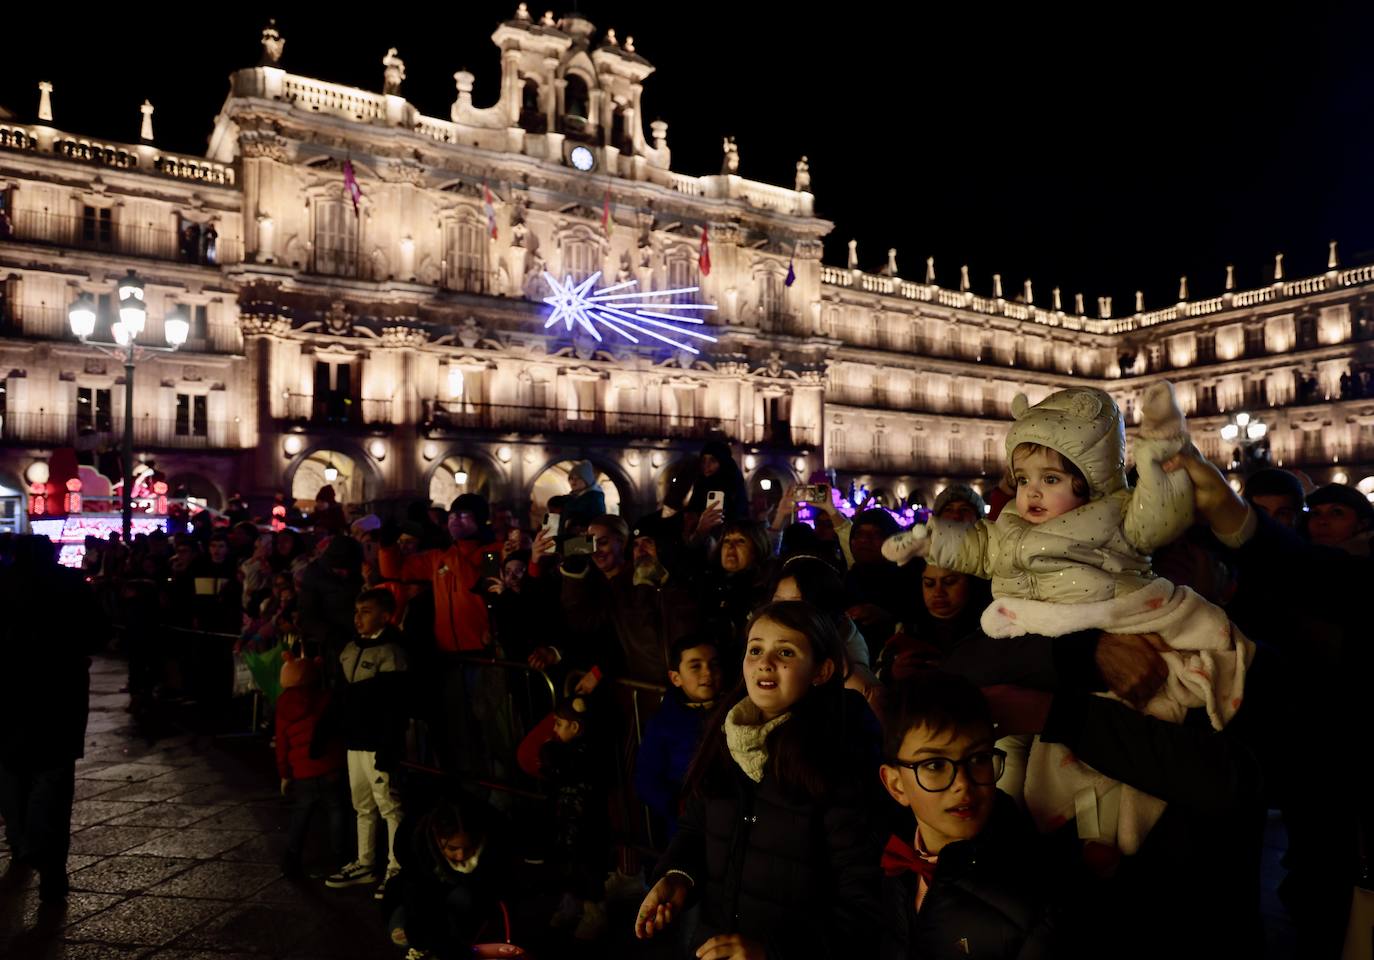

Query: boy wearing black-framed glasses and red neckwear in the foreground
<box><xmin>879</xmin><ymin>672</ymin><xmax>1055</xmax><ymax>960</ymax></box>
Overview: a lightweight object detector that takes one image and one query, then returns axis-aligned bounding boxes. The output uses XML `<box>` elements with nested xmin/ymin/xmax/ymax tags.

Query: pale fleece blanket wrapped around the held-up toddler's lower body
<box><xmin>982</xmin><ymin>580</ymin><xmax>1254</xmax><ymax>854</ymax></box>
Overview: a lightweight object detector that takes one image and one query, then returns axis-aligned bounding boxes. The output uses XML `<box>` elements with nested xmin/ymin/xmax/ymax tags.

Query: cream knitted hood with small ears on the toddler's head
<box><xmin>1007</xmin><ymin>387</ymin><xmax>1125</xmax><ymax>500</ymax></box>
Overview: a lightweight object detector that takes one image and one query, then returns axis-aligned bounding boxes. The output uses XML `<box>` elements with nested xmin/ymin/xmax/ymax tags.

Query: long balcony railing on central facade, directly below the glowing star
<box><xmin>420</xmin><ymin>400</ymin><xmax>819</xmax><ymax>446</ymax></box>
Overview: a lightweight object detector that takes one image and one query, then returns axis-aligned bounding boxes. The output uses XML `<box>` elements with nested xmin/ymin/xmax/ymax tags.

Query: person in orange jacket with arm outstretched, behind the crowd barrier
<box><xmin>378</xmin><ymin>493</ymin><xmax>502</xmax><ymax>654</ymax></box>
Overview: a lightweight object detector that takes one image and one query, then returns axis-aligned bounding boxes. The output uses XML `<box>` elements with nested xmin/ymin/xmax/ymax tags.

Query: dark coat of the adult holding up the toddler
<box><xmin>941</xmin><ymin>632</ymin><xmax>1264</xmax><ymax>957</ymax></box>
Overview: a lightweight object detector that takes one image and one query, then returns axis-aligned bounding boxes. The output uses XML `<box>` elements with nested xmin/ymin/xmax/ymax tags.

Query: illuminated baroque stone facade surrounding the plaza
<box><xmin>0</xmin><ymin>5</ymin><xmax>1374</xmax><ymax>524</ymax></box>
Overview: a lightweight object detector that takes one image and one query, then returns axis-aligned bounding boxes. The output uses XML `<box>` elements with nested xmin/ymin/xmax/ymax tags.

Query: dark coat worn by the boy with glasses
<box><xmin>881</xmin><ymin>791</ymin><xmax>1059</xmax><ymax>960</ymax></box>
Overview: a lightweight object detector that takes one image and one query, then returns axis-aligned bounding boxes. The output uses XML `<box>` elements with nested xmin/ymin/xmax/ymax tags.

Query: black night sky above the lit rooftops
<box><xmin>0</xmin><ymin>0</ymin><xmax>1374</xmax><ymax>316</ymax></box>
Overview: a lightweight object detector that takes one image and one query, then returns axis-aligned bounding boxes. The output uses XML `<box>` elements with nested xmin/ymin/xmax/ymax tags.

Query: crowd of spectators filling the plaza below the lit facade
<box><xmin>0</xmin><ymin>420</ymin><xmax>1374</xmax><ymax>960</ymax></box>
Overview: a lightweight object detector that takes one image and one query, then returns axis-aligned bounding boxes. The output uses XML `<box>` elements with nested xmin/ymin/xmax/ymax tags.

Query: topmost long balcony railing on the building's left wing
<box><xmin>0</xmin><ymin>210</ymin><xmax>243</xmax><ymax>266</ymax></box>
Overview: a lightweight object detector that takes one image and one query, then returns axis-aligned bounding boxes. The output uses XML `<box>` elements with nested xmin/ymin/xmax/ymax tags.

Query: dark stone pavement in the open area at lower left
<box><xmin>0</xmin><ymin>658</ymin><xmax>401</xmax><ymax>960</ymax></box>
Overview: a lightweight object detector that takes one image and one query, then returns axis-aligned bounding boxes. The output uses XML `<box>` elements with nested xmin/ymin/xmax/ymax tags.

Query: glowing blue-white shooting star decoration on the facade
<box><xmin>544</xmin><ymin>273</ymin><xmax>716</xmax><ymax>353</ymax></box>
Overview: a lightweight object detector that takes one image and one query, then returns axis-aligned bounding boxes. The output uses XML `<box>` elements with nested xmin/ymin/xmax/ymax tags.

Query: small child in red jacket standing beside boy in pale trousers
<box><xmin>276</xmin><ymin>654</ymin><xmax>349</xmax><ymax>878</ymax></box>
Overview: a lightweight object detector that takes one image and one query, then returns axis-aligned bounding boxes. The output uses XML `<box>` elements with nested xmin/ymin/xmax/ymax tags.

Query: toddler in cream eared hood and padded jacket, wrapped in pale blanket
<box><xmin>883</xmin><ymin>383</ymin><xmax>1253</xmax><ymax>853</ymax></box>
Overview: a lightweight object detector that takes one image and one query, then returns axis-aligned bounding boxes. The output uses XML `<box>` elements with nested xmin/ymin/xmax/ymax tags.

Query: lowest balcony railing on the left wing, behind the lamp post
<box><xmin>0</xmin><ymin>411</ymin><xmax>239</xmax><ymax>450</ymax></box>
